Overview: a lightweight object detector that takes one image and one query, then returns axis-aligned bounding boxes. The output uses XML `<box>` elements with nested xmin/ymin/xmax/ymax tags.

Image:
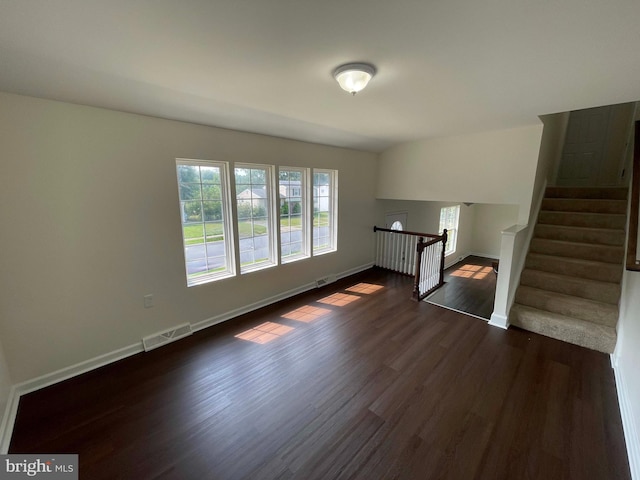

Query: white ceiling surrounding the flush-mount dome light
<box><xmin>0</xmin><ymin>0</ymin><xmax>640</xmax><ymax>151</ymax></box>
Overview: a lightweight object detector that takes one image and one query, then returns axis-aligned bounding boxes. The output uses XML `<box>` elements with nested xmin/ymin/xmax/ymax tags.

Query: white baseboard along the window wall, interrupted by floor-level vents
<box><xmin>0</xmin><ymin>263</ymin><xmax>373</xmax><ymax>454</ymax></box>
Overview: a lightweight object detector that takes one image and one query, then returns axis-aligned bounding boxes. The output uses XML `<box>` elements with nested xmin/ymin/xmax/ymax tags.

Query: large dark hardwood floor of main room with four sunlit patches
<box><xmin>10</xmin><ymin>269</ymin><xmax>630</xmax><ymax>480</ymax></box>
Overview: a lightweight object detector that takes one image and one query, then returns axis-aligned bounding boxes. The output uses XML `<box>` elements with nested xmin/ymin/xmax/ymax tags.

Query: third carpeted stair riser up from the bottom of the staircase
<box><xmin>520</xmin><ymin>269</ymin><xmax>620</xmax><ymax>305</ymax></box>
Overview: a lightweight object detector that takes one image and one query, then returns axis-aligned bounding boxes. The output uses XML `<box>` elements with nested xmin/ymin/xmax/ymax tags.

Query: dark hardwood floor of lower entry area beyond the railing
<box><xmin>426</xmin><ymin>255</ymin><xmax>496</xmax><ymax>320</ymax></box>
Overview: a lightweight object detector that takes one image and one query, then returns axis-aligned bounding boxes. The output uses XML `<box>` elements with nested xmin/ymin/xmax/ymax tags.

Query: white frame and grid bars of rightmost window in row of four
<box><xmin>311</xmin><ymin>168</ymin><xmax>338</xmax><ymax>255</ymax></box>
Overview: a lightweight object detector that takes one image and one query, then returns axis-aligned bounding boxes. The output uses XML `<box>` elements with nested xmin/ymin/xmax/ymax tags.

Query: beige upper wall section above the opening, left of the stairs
<box><xmin>376</xmin><ymin>124</ymin><xmax>542</xmax><ymax>223</ymax></box>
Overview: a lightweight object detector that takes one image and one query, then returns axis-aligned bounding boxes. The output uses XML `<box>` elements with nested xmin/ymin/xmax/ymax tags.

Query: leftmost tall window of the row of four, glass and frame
<box><xmin>176</xmin><ymin>159</ymin><xmax>235</xmax><ymax>286</ymax></box>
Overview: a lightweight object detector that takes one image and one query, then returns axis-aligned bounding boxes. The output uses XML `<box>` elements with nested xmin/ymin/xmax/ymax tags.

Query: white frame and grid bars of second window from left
<box><xmin>233</xmin><ymin>163</ymin><xmax>278</xmax><ymax>274</ymax></box>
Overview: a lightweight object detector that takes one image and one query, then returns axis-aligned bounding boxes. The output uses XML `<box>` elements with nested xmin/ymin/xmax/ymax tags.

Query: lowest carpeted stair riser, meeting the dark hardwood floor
<box><xmin>509</xmin><ymin>305</ymin><xmax>616</xmax><ymax>353</ymax></box>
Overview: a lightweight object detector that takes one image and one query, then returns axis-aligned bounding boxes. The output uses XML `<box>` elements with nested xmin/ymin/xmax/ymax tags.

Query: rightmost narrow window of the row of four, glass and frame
<box><xmin>313</xmin><ymin>169</ymin><xmax>338</xmax><ymax>254</ymax></box>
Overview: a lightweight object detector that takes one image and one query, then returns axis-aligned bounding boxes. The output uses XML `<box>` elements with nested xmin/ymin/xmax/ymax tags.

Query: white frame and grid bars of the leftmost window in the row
<box><xmin>176</xmin><ymin>158</ymin><xmax>236</xmax><ymax>287</ymax></box>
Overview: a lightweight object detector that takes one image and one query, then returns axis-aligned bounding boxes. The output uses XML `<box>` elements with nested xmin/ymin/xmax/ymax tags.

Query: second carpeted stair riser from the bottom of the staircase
<box><xmin>516</xmin><ymin>287</ymin><xmax>618</xmax><ymax>327</ymax></box>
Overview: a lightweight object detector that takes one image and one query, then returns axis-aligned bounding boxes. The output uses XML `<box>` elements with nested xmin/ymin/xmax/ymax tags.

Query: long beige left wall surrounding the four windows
<box><xmin>0</xmin><ymin>94</ymin><xmax>376</xmax><ymax>382</ymax></box>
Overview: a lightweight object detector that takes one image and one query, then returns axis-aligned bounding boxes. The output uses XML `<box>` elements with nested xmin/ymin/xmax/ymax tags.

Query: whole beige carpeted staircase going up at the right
<box><xmin>509</xmin><ymin>187</ymin><xmax>627</xmax><ymax>353</ymax></box>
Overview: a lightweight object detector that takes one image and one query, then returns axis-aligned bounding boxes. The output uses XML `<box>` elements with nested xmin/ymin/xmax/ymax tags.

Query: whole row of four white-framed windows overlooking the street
<box><xmin>176</xmin><ymin>158</ymin><xmax>338</xmax><ymax>286</ymax></box>
